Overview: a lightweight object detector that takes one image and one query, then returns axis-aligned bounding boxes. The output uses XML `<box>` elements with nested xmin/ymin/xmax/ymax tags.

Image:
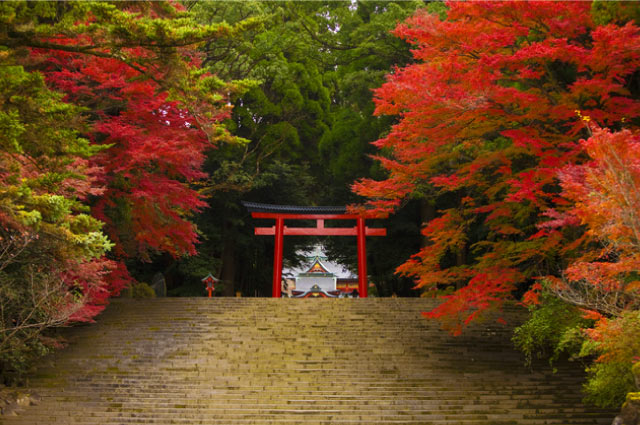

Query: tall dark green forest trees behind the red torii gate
<box><xmin>174</xmin><ymin>1</ymin><xmax>420</xmax><ymax>294</ymax></box>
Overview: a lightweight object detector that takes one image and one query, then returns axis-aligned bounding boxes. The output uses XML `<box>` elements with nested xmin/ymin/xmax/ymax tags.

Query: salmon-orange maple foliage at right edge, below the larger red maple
<box><xmin>543</xmin><ymin>124</ymin><xmax>640</xmax><ymax>317</ymax></box>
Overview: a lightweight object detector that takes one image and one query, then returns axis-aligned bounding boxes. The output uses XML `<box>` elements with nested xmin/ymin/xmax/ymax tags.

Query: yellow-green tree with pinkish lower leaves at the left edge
<box><xmin>0</xmin><ymin>63</ymin><xmax>113</xmax><ymax>382</ymax></box>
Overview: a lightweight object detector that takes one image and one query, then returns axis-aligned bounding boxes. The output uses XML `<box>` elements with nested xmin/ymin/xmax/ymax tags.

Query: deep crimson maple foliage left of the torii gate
<box><xmin>39</xmin><ymin>44</ymin><xmax>216</xmax><ymax>259</ymax></box>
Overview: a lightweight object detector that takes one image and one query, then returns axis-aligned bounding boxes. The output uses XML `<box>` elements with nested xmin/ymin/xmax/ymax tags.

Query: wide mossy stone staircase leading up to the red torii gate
<box><xmin>0</xmin><ymin>298</ymin><xmax>615</xmax><ymax>425</ymax></box>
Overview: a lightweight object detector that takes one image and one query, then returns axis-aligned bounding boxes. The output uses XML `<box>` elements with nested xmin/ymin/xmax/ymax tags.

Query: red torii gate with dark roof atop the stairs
<box><xmin>242</xmin><ymin>202</ymin><xmax>387</xmax><ymax>298</ymax></box>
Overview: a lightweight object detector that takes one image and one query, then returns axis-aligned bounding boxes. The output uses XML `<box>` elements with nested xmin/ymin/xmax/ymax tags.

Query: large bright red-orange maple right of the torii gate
<box><xmin>353</xmin><ymin>1</ymin><xmax>640</xmax><ymax>331</ymax></box>
